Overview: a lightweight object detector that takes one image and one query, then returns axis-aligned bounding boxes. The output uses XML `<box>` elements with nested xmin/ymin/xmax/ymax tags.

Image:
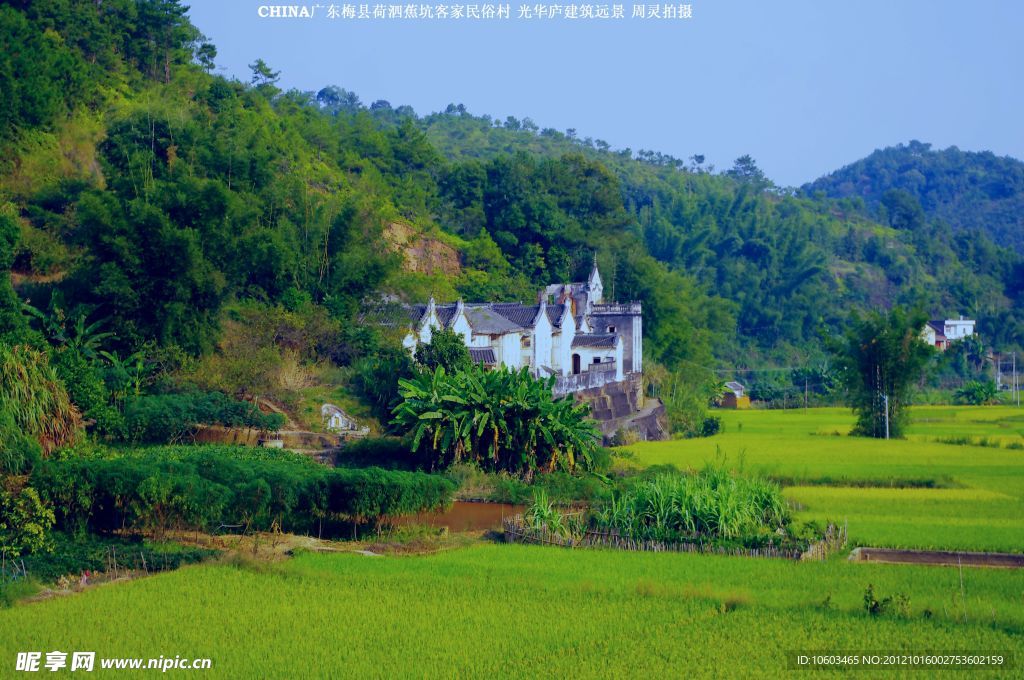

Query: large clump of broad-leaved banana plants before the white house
<box><xmin>392</xmin><ymin>366</ymin><xmax>600</xmax><ymax>477</ymax></box>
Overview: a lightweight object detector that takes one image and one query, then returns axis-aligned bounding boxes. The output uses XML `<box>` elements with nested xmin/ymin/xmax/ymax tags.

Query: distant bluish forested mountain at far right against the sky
<box><xmin>801</xmin><ymin>141</ymin><xmax>1024</xmax><ymax>252</ymax></box>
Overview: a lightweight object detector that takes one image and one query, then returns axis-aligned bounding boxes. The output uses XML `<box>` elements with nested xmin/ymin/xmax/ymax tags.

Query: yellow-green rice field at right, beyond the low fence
<box><xmin>629</xmin><ymin>407</ymin><xmax>1024</xmax><ymax>552</ymax></box>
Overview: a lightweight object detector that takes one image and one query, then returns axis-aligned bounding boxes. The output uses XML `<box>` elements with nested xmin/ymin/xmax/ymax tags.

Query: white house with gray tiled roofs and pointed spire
<box><xmin>403</xmin><ymin>261</ymin><xmax>643</xmax><ymax>393</ymax></box>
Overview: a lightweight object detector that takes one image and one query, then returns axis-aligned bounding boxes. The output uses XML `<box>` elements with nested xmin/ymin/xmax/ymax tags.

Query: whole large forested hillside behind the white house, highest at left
<box><xmin>0</xmin><ymin>0</ymin><xmax>1024</xmax><ymax>403</ymax></box>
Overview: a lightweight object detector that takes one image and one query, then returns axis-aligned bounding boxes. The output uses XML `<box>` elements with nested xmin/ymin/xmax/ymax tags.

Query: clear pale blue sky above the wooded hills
<box><xmin>185</xmin><ymin>0</ymin><xmax>1024</xmax><ymax>186</ymax></box>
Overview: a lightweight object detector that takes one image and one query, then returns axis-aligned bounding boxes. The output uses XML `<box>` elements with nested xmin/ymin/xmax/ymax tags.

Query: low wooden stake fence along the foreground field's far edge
<box><xmin>502</xmin><ymin>515</ymin><xmax>846</xmax><ymax>560</ymax></box>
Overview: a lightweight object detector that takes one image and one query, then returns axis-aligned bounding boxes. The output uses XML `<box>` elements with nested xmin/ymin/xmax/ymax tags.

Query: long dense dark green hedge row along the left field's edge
<box><xmin>32</xmin><ymin>449</ymin><xmax>456</xmax><ymax>536</ymax></box>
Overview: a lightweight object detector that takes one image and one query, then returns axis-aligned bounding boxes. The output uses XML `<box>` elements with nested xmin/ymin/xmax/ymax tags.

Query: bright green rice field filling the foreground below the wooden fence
<box><xmin>0</xmin><ymin>545</ymin><xmax>1024</xmax><ymax>678</ymax></box>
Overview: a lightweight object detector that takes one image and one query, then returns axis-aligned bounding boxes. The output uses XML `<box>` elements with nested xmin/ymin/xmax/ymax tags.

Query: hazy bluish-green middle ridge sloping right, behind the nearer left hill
<box><xmin>411</xmin><ymin>111</ymin><xmax>1024</xmax><ymax>356</ymax></box>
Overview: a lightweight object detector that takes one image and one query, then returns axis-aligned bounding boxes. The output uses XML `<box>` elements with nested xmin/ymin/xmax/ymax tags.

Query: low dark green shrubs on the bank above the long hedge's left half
<box><xmin>124</xmin><ymin>392</ymin><xmax>285</xmax><ymax>443</ymax></box>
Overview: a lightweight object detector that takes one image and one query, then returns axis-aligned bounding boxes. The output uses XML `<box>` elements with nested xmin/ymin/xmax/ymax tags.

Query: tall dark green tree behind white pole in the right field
<box><xmin>834</xmin><ymin>307</ymin><xmax>935</xmax><ymax>437</ymax></box>
